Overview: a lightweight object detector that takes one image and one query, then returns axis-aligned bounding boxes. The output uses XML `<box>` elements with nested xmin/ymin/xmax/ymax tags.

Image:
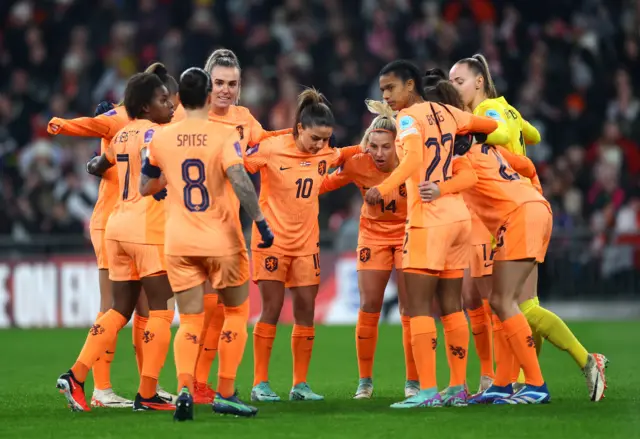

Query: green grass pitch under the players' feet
<box><xmin>0</xmin><ymin>322</ymin><xmax>640</xmax><ymax>439</ymax></box>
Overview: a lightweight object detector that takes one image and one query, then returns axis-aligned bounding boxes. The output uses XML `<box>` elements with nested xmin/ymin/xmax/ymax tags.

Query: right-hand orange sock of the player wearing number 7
<box><xmin>138</xmin><ymin>310</ymin><xmax>175</xmax><ymax>398</ymax></box>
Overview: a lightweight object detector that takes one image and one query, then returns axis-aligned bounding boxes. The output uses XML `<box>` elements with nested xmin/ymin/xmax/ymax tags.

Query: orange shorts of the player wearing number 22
<box><xmin>402</xmin><ymin>220</ymin><xmax>471</xmax><ymax>271</ymax></box>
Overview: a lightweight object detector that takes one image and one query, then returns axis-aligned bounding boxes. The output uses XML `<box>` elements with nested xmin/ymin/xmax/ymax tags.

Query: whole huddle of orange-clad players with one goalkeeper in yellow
<box><xmin>49</xmin><ymin>49</ymin><xmax>607</xmax><ymax>420</ymax></box>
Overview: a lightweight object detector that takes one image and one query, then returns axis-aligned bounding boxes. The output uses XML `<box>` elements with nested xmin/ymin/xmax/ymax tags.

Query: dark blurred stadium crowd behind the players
<box><xmin>0</xmin><ymin>0</ymin><xmax>640</xmax><ymax>257</ymax></box>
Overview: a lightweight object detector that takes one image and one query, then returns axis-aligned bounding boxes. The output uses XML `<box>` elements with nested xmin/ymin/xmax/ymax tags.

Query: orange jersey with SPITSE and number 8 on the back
<box><xmin>149</xmin><ymin>119</ymin><xmax>246</xmax><ymax>257</ymax></box>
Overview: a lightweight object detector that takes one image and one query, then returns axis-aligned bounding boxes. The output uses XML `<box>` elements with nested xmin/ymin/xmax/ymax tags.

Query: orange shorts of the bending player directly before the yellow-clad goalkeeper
<box><xmin>494</xmin><ymin>201</ymin><xmax>553</xmax><ymax>262</ymax></box>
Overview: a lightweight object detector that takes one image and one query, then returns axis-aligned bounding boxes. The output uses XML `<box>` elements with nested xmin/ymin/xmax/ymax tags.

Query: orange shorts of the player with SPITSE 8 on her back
<box><xmin>165</xmin><ymin>250</ymin><xmax>249</xmax><ymax>293</ymax></box>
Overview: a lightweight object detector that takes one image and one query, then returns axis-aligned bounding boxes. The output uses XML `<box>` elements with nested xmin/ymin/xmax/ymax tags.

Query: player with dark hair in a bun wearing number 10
<box><xmin>245</xmin><ymin>89</ymin><xmax>361</xmax><ymax>401</ymax></box>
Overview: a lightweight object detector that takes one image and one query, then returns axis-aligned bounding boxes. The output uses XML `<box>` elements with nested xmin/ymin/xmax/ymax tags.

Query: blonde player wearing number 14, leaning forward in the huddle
<box><xmin>320</xmin><ymin>100</ymin><xmax>420</xmax><ymax>399</ymax></box>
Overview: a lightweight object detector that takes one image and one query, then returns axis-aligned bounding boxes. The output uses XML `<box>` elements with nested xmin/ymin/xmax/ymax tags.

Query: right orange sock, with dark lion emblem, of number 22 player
<box><xmin>440</xmin><ymin>311</ymin><xmax>469</xmax><ymax>387</ymax></box>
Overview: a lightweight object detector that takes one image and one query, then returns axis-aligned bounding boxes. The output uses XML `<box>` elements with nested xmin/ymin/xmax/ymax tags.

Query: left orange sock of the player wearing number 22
<box><xmin>411</xmin><ymin>316</ymin><xmax>438</xmax><ymax>390</ymax></box>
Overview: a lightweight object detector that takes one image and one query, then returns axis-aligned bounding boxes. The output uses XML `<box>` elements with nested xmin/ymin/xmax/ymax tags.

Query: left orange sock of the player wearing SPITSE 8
<box><xmin>173</xmin><ymin>312</ymin><xmax>204</xmax><ymax>394</ymax></box>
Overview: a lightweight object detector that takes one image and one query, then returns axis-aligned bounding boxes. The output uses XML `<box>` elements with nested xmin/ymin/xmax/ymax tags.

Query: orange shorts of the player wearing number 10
<box><xmin>251</xmin><ymin>251</ymin><xmax>320</xmax><ymax>288</ymax></box>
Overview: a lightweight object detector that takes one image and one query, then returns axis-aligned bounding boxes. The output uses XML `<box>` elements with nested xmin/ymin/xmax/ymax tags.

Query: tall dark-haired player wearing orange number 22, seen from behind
<box><xmin>365</xmin><ymin>60</ymin><xmax>497</xmax><ymax>408</ymax></box>
